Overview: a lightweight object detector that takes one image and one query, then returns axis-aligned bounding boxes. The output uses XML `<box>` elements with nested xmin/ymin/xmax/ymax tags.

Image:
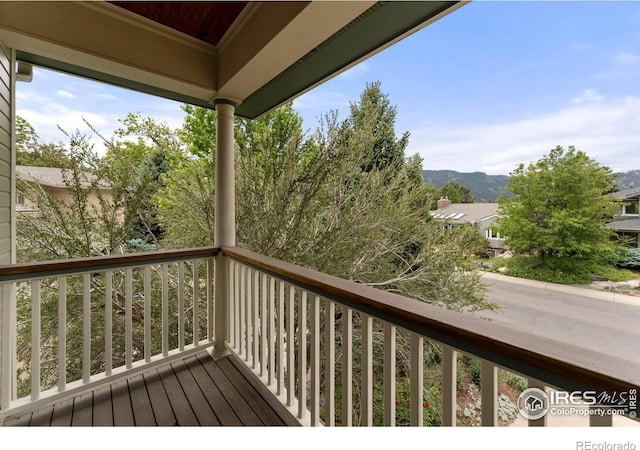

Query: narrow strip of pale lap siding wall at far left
<box><xmin>0</xmin><ymin>42</ymin><xmax>15</xmax><ymax>264</ymax></box>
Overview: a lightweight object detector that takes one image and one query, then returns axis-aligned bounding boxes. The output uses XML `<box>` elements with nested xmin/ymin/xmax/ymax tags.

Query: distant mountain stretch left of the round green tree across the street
<box><xmin>422</xmin><ymin>170</ymin><xmax>509</xmax><ymax>203</ymax></box>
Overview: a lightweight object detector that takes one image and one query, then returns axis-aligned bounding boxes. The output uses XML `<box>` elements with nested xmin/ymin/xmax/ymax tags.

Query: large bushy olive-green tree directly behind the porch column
<box><xmin>156</xmin><ymin>90</ymin><xmax>490</xmax><ymax>309</ymax></box>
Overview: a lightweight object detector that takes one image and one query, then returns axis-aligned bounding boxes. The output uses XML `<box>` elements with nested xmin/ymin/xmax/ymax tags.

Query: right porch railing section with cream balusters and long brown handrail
<box><xmin>222</xmin><ymin>248</ymin><xmax>640</xmax><ymax>426</ymax></box>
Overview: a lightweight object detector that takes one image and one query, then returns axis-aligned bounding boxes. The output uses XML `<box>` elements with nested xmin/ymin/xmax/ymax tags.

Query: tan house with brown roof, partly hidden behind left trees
<box><xmin>16</xmin><ymin>166</ymin><xmax>113</xmax><ymax>214</ymax></box>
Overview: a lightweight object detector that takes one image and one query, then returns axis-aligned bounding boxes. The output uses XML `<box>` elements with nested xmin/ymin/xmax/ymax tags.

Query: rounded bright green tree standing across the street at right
<box><xmin>499</xmin><ymin>146</ymin><xmax>616</xmax><ymax>265</ymax></box>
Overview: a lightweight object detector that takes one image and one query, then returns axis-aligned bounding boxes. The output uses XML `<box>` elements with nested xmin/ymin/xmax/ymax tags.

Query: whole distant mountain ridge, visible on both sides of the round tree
<box><xmin>422</xmin><ymin>170</ymin><xmax>640</xmax><ymax>203</ymax></box>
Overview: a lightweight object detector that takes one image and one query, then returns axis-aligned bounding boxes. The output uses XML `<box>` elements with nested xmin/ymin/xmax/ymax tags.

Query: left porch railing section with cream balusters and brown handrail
<box><xmin>0</xmin><ymin>248</ymin><xmax>217</xmax><ymax>420</ymax></box>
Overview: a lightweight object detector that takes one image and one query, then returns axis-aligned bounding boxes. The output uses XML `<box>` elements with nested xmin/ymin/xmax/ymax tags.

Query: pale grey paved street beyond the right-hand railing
<box><xmin>476</xmin><ymin>274</ymin><xmax>640</xmax><ymax>361</ymax></box>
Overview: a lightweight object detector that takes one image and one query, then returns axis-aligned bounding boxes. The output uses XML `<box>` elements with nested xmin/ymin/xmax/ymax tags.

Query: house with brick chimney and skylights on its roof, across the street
<box><xmin>431</xmin><ymin>198</ymin><xmax>506</xmax><ymax>255</ymax></box>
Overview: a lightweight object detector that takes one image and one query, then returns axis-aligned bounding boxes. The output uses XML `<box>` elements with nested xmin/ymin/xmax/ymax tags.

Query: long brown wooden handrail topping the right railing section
<box><xmin>221</xmin><ymin>247</ymin><xmax>640</xmax><ymax>393</ymax></box>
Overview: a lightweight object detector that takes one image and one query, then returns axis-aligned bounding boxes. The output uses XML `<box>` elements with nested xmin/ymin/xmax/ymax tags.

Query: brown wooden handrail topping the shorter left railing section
<box><xmin>0</xmin><ymin>247</ymin><xmax>219</xmax><ymax>283</ymax></box>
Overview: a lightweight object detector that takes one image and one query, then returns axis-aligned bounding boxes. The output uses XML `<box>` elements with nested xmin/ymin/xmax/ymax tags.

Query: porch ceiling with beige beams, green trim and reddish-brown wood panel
<box><xmin>0</xmin><ymin>0</ymin><xmax>466</xmax><ymax>118</ymax></box>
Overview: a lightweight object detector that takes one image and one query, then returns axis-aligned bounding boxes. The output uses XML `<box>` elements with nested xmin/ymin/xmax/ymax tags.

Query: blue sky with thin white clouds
<box><xmin>17</xmin><ymin>0</ymin><xmax>640</xmax><ymax>175</ymax></box>
